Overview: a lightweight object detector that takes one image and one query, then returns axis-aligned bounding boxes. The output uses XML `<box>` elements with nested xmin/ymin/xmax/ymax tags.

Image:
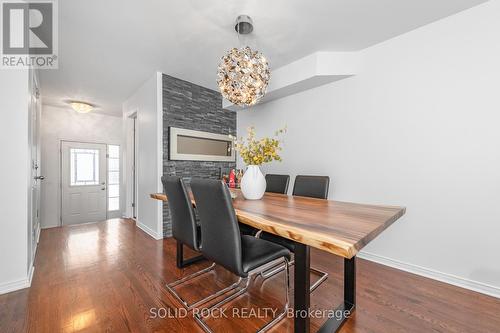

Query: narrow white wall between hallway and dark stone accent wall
<box><xmin>123</xmin><ymin>73</ymin><xmax>163</xmax><ymax>239</ymax></box>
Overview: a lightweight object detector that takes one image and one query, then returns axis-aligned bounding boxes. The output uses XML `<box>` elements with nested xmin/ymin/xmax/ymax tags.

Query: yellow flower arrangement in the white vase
<box><xmin>233</xmin><ymin>126</ymin><xmax>286</xmax><ymax>165</ymax></box>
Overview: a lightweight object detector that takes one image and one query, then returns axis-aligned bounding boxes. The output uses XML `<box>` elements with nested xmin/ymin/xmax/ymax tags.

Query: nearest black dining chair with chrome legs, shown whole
<box><xmin>191</xmin><ymin>179</ymin><xmax>290</xmax><ymax>332</ymax></box>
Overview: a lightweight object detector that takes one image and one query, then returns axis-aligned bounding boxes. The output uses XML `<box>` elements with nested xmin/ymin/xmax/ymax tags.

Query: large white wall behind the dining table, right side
<box><xmin>238</xmin><ymin>1</ymin><xmax>500</xmax><ymax>296</ymax></box>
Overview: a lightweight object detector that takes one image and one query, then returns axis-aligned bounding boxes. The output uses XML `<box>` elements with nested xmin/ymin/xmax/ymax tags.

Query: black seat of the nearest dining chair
<box><xmin>241</xmin><ymin>235</ymin><xmax>290</xmax><ymax>273</ymax></box>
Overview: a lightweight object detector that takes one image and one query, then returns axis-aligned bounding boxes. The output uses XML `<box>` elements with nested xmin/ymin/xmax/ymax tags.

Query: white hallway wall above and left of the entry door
<box><xmin>41</xmin><ymin>105</ymin><xmax>123</xmax><ymax>228</ymax></box>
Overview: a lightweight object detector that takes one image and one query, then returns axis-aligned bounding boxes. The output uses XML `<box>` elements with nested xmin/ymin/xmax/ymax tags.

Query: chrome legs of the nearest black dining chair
<box><xmin>194</xmin><ymin>258</ymin><xmax>290</xmax><ymax>333</ymax></box>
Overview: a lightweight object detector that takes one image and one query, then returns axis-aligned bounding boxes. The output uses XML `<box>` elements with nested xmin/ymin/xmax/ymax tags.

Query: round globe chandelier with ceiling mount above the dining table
<box><xmin>217</xmin><ymin>15</ymin><xmax>271</xmax><ymax>106</ymax></box>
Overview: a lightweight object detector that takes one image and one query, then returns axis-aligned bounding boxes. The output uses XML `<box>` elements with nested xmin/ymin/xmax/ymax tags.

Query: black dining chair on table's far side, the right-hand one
<box><xmin>256</xmin><ymin>175</ymin><xmax>330</xmax><ymax>291</ymax></box>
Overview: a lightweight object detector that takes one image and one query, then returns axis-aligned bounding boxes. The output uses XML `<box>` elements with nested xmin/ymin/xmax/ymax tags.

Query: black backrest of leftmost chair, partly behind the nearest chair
<box><xmin>161</xmin><ymin>176</ymin><xmax>200</xmax><ymax>251</ymax></box>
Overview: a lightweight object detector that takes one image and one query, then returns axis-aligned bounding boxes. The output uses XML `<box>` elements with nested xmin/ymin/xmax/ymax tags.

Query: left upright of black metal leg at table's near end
<box><xmin>293</xmin><ymin>243</ymin><xmax>311</xmax><ymax>333</ymax></box>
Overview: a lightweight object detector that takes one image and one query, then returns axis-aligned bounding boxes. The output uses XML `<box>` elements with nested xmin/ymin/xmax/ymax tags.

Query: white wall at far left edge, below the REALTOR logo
<box><xmin>0</xmin><ymin>69</ymin><xmax>31</xmax><ymax>294</ymax></box>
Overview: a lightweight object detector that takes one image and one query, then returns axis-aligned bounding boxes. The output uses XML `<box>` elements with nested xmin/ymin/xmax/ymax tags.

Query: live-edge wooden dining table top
<box><xmin>151</xmin><ymin>190</ymin><xmax>405</xmax><ymax>258</ymax></box>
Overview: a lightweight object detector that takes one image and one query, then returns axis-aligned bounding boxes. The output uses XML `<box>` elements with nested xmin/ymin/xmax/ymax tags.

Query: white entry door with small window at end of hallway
<box><xmin>61</xmin><ymin>141</ymin><xmax>107</xmax><ymax>225</ymax></box>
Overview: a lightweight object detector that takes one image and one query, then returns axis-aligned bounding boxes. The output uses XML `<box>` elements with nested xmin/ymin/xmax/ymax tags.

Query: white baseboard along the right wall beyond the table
<box><xmin>357</xmin><ymin>251</ymin><xmax>500</xmax><ymax>298</ymax></box>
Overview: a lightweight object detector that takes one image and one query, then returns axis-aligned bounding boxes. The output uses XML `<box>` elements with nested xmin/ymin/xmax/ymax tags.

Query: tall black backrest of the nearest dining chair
<box><xmin>191</xmin><ymin>179</ymin><xmax>245</xmax><ymax>276</ymax></box>
